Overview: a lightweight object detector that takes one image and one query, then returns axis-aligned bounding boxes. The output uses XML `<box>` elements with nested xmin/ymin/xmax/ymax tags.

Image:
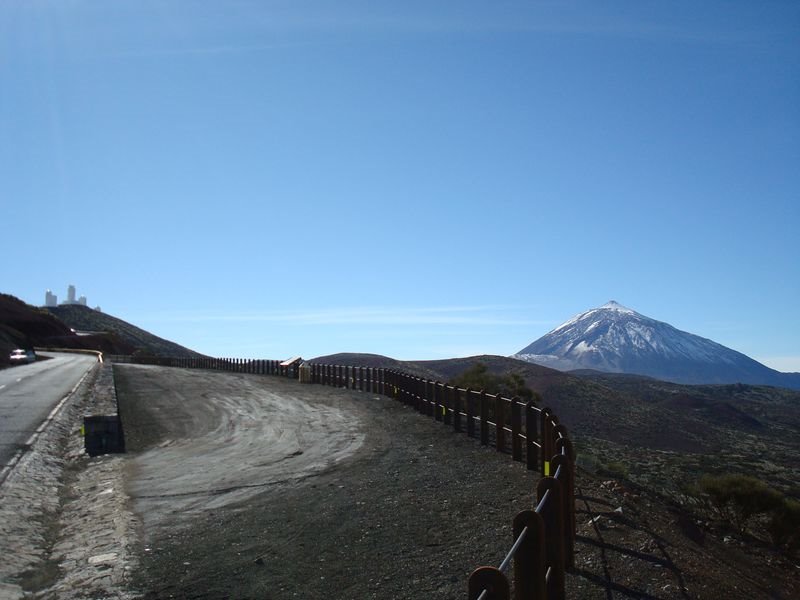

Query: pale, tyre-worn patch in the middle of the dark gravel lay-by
<box><xmin>115</xmin><ymin>365</ymin><xmax>364</xmax><ymax>531</ymax></box>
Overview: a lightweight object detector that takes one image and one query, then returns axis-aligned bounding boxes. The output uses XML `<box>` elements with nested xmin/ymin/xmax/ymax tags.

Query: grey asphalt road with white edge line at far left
<box><xmin>0</xmin><ymin>353</ymin><xmax>97</xmax><ymax>469</ymax></box>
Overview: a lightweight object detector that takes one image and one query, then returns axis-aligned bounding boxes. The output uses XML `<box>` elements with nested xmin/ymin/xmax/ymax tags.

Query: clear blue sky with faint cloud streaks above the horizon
<box><xmin>0</xmin><ymin>0</ymin><xmax>800</xmax><ymax>371</ymax></box>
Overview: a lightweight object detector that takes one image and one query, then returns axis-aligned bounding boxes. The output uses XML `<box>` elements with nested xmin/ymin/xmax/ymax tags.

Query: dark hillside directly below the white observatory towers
<box><xmin>44</xmin><ymin>304</ymin><xmax>201</xmax><ymax>358</ymax></box>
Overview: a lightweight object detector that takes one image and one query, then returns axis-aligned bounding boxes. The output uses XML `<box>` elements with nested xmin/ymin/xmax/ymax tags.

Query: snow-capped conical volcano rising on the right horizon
<box><xmin>514</xmin><ymin>300</ymin><xmax>800</xmax><ymax>388</ymax></box>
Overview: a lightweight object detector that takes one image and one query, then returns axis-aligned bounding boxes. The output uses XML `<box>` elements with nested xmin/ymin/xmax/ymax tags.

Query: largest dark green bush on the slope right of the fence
<box><xmin>697</xmin><ymin>474</ymin><xmax>784</xmax><ymax>532</ymax></box>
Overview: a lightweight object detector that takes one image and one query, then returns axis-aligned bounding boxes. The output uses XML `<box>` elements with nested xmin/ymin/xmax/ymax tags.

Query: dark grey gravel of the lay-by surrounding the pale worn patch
<box><xmin>117</xmin><ymin>367</ymin><xmax>536</xmax><ymax>599</ymax></box>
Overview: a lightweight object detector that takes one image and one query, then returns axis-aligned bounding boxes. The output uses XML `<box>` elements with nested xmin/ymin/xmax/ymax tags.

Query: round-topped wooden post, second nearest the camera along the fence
<box><xmin>513</xmin><ymin>510</ymin><xmax>547</xmax><ymax>600</ymax></box>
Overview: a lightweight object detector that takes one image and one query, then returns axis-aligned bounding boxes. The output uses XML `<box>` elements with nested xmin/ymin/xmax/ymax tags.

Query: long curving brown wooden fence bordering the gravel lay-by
<box><xmin>106</xmin><ymin>355</ymin><xmax>575</xmax><ymax>600</ymax></box>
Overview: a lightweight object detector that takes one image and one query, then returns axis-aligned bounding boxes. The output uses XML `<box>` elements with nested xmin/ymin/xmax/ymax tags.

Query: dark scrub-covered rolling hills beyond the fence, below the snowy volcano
<box><xmin>314</xmin><ymin>354</ymin><xmax>800</xmax><ymax>498</ymax></box>
